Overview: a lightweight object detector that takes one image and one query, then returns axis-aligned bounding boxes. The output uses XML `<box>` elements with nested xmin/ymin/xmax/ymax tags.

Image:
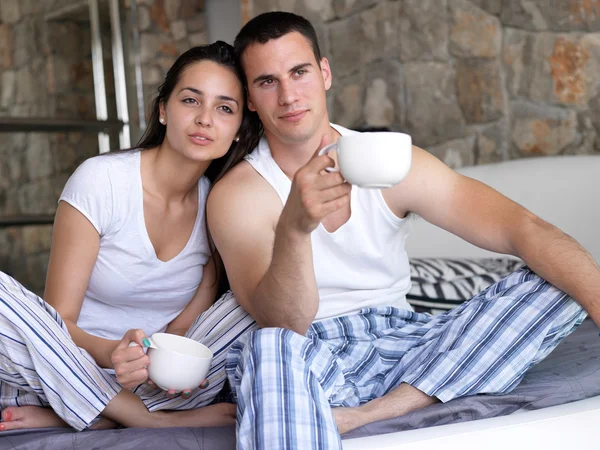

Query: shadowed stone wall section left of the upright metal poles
<box><xmin>0</xmin><ymin>0</ymin><xmax>98</xmax><ymax>293</ymax></box>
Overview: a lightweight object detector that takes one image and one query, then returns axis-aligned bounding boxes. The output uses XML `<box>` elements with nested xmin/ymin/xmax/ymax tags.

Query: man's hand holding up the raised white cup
<box><xmin>280</xmin><ymin>142</ymin><xmax>351</xmax><ymax>234</ymax></box>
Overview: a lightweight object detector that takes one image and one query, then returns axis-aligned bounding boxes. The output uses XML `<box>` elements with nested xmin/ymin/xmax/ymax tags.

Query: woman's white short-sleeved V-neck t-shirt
<box><xmin>59</xmin><ymin>151</ymin><xmax>210</xmax><ymax>340</ymax></box>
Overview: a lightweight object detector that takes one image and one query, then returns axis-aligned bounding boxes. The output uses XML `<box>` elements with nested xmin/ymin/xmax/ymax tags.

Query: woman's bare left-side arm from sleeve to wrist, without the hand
<box><xmin>44</xmin><ymin>201</ymin><xmax>119</xmax><ymax>368</ymax></box>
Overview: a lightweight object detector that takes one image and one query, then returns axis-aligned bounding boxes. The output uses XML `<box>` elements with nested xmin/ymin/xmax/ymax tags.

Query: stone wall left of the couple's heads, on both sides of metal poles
<box><xmin>0</xmin><ymin>0</ymin><xmax>206</xmax><ymax>294</ymax></box>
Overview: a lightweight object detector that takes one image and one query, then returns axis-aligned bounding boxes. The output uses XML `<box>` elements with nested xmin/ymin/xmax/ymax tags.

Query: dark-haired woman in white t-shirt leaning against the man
<box><xmin>0</xmin><ymin>42</ymin><xmax>258</xmax><ymax>431</ymax></box>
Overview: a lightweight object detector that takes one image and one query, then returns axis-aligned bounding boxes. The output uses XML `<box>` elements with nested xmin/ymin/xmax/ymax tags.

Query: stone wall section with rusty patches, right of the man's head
<box><xmin>253</xmin><ymin>0</ymin><xmax>600</xmax><ymax>168</ymax></box>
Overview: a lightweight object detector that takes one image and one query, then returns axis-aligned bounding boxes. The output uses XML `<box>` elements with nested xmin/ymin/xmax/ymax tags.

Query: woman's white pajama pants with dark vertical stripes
<box><xmin>0</xmin><ymin>272</ymin><xmax>256</xmax><ymax>430</ymax></box>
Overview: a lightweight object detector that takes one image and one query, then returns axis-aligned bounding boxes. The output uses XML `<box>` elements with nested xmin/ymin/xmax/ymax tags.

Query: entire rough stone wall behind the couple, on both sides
<box><xmin>0</xmin><ymin>0</ymin><xmax>600</xmax><ymax>293</ymax></box>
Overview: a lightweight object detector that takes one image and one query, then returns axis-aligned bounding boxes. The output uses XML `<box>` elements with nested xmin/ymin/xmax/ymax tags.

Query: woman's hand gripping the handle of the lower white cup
<box><xmin>110</xmin><ymin>330</ymin><xmax>150</xmax><ymax>389</ymax></box>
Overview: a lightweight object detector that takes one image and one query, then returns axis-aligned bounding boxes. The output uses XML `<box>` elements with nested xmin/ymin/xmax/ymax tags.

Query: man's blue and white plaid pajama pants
<box><xmin>226</xmin><ymin>268</ymin><xmax>586</xmax><ymax>450</ymax></box>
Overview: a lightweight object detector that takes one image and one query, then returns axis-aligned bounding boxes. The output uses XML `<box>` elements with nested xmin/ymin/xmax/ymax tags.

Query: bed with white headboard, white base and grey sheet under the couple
<box><xmin>0</xmin><ymin>155</ymin><xmax>600</xmax><ymax>450</ymax></box>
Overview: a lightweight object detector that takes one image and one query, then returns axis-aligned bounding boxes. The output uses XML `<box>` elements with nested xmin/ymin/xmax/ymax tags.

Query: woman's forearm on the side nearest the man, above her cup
<box><xmin>166</xmin><ymin>254</ymin><xmax>221</xmax><ymax>336</ymax></box>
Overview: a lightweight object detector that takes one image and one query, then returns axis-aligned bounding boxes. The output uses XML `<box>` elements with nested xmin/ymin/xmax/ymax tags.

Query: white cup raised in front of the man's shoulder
<box><xmin>319</xmin><ymin>132</ymin><xmax>412</xmax><ymax>189</ymax></box>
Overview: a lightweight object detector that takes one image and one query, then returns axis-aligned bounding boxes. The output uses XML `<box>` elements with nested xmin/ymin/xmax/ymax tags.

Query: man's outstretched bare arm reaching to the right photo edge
<box><xmin>384</xmin><ymin>147</ymin><xmax>600</xmax><ymax>325</ymax></box>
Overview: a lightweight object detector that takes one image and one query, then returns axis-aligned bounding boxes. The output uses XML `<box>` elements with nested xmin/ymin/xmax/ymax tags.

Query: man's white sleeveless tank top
<box><xmin>246</xmin><ymin>124</ymin><xmax>412</xmax><ymax>320</ymax></box>
